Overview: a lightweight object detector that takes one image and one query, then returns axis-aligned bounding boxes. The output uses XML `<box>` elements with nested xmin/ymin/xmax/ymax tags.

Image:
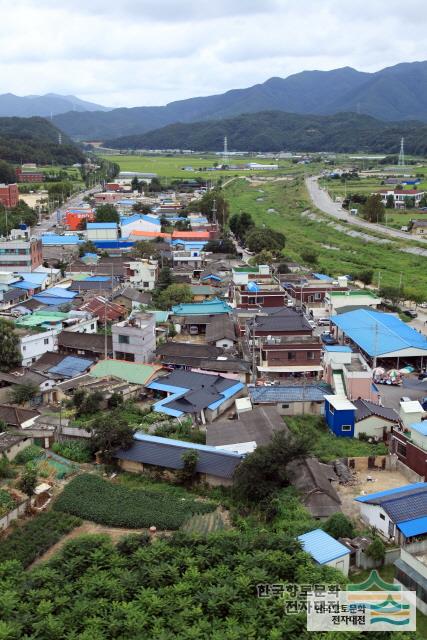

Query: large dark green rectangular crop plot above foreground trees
<box><xmin>54</xmin><ymin>474</ymin><xmax>215</xmax><ymax>529</ymax></box>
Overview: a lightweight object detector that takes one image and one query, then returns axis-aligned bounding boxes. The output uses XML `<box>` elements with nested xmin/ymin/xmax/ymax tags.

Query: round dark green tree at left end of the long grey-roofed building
<box><xmin>90</xmin><ymin>412</ymin><xmax>134</xmax><ymax>462</ymax></box>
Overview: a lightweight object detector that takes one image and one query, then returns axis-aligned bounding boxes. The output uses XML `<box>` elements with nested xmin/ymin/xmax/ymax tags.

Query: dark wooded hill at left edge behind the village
<box><xmin>0</xmin><ymin>117</ymin><xmax>84</xmax><ymax>165</ymax></box>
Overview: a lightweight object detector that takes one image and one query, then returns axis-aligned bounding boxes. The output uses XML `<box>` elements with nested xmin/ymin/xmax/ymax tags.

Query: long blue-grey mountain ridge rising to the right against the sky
<box><xmin>54</xmin><ymin>61</ymin><xmax>427</xmax><ymax>140</ymax></box>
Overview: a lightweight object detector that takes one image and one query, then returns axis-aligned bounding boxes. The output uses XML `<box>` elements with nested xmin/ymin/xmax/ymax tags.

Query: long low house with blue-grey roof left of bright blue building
<box><xmin>248</xmin><ymin>381</ymin><xmax>331</xmax><ymax>416</ymax></box>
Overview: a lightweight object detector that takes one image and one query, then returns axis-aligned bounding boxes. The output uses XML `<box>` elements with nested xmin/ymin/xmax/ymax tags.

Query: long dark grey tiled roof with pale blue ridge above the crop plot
<box><xmin>115</xmin><ymin>439</ymin><xmax>241</xmax><ymax>478</ymax></box>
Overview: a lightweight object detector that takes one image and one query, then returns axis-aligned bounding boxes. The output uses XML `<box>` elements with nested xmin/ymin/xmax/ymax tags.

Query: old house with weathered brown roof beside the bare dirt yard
<box><xmin>286</xmin><ymin>458</ymin><xmax>341</xmax><ymax>519</ymax></box>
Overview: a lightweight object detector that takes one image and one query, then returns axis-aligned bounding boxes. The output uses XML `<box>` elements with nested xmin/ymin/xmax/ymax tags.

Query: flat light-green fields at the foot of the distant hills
<box><xmin>101</xmin><ymin>154</ymin><xmax>310</xmax><ymax>182</ymax></box>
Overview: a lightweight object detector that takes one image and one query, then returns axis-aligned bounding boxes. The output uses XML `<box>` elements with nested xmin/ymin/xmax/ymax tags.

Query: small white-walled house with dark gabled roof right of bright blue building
<box><xmin>352</xmin><ymin>399</ymin><xmax>400</xmax><ymax>440</ymax></box>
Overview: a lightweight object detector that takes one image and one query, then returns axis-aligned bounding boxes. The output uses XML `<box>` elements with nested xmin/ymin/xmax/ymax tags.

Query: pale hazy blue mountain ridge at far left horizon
<box><xmin>0</xmin><ymin>93</ymin><xmax>108</xmax><ymax>118</ymax></box>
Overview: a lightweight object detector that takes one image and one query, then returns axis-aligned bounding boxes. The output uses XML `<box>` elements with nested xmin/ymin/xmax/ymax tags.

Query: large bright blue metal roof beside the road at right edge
<box><xmin>331</xmin><ymin>309</ymin><xmax>427</xmax><ymax>356</ymax></box>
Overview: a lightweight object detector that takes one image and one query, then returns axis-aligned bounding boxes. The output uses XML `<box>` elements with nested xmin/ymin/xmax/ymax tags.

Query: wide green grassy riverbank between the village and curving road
<box><xmin>225</xmin><ymin>178</ymin><xmax>427</xmax><ymax>300</ymax></box>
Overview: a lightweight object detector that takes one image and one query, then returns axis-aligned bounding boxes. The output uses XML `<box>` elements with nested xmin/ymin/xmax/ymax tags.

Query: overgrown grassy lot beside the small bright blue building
<box><xmin>286</xmin><ymin>415</ymin><xmax>387</xmax><ymax>462</ymax></box>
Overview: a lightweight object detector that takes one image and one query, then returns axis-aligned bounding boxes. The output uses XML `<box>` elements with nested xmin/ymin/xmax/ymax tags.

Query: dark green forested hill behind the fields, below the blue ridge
<box><xmin>104</xmin><ymin>111</ymin><xmax>427</xmax><ymax>155</ymax></box>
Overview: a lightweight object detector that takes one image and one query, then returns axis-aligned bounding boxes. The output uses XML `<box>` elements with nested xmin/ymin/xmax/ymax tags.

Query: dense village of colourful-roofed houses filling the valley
<box><xmin>0</xmin><ymin>161</ymin><xmax>427</xmax><ymax>632</ymax></box>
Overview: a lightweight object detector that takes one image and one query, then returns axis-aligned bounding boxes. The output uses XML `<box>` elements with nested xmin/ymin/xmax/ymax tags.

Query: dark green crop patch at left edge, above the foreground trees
<box><xmin>0</xmin><ymin>511</ymin><xmax>81</xmax><ymax>567</ymax></box>
